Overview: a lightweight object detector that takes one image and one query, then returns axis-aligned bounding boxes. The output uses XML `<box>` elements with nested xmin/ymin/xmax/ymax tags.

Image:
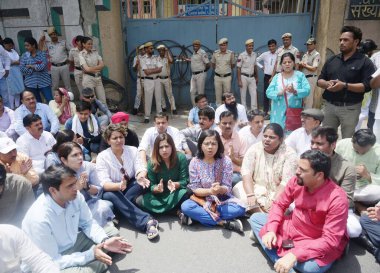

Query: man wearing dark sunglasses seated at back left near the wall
<box><xmin>80</xmin><ymin>87</ymin><xmax>112</xmax><ymax>128</ymax></box>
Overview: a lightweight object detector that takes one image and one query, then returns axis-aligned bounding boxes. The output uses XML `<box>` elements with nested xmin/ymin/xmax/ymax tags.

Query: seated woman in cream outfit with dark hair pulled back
<box><xmin>233</xmin><ymin>123</ymin><xmax>298</xmax><ymax>212</ymax></box>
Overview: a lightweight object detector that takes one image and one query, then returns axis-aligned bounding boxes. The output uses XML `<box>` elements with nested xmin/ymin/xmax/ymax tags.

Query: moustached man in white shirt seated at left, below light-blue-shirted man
<box><xmin>16</xmin><ymin>114</ymin><xmax>56</xmax><ymax>173</ymax></box>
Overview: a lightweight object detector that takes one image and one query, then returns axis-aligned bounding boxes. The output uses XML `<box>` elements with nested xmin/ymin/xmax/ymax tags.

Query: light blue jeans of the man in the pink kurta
<box><xmin>249</xmin><ymin>213</ymin><xmax>332</xmax><ymax>273</ymax></box>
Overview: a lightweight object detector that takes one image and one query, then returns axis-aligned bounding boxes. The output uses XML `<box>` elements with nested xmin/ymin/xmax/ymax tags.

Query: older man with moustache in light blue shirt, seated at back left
<box><xmin>15</xmin><ymin>90</ymin><xmax>59</xmax><ymax>136</ymax></box>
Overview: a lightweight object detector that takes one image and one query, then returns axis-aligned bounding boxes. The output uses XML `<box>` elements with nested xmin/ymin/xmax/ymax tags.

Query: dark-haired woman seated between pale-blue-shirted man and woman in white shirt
<box><xmin>58</xmin><ymin>142</ymin><xmax>115</xmax><ymax>227</ymax></box>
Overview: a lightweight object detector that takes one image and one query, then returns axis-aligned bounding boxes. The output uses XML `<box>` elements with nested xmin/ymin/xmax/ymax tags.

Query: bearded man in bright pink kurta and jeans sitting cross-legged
<box><xmin>249</xmin><ymin>151</ymin><xmax>348</xmax><ymax>273</ymax></box>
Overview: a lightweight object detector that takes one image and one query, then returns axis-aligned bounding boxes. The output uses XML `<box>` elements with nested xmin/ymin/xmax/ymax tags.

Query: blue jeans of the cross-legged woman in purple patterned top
<box><xmin>181</xmin><ymin>199</ymin><xmax>245</xmax><ymax>227</ymax></box>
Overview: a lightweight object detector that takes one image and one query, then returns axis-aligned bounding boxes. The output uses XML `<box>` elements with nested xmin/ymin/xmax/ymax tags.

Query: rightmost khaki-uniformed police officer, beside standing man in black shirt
<box><xmin>299</xmin><ymin>38</ymin><xmax>321</xmax><ymax>109</ymax></box>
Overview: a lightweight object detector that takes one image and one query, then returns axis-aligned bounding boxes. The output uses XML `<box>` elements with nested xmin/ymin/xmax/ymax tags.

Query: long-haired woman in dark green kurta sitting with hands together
<box><xmin>141</xmin><ymin>133</ymin><xmax>189</xmax><ymax>213</ymax></box>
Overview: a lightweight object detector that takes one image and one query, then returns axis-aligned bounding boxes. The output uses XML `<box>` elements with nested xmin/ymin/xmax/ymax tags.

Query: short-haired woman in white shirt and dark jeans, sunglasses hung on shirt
<box><xmin>96</xmin><ymin>124</ymin><xmax>158</xmax><ymax>240</ymax></box>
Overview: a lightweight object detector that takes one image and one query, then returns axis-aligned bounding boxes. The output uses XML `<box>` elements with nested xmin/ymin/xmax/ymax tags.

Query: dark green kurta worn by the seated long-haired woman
<box><xmin>142</xmin><ymin>153</ymin><xmax>189</xmax><ymax>213</ymax></box>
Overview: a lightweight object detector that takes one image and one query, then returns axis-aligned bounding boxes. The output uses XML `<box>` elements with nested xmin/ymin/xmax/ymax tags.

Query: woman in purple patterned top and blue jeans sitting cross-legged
<box><xmin>180</xmin><ymin>130</ymin><xmax>245</xmax><ymax>232</ymax></box>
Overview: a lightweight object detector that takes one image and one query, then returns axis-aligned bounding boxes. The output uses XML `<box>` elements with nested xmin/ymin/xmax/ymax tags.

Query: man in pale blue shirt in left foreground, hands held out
<box><xmin>22</xmin><ymin>166</ymin><xmax>132</xmax><ymax>273</ymax></box>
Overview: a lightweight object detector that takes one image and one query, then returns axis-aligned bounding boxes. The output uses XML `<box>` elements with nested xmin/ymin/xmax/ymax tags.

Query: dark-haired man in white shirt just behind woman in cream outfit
<box><xmin>239</xmin><ymin>109</ymin><xmax>265</xmax><ymax>150</ymax></box>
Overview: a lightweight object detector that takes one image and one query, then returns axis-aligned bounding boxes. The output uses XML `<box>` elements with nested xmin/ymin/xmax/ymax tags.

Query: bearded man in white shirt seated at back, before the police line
<box><xmin>215</xmin><ymin>92</ymin><xmax>248</xmax><ymax>130</ymax></box>
